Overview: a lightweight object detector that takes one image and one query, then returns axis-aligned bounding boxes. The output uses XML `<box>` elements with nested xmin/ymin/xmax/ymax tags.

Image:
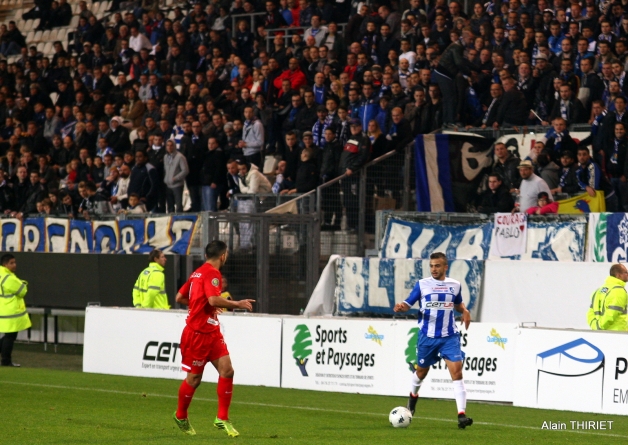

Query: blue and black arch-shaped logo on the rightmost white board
<box><xmin>536</xmin><ymin>338</ymin><xmax>605</xmax><ymax>409</ymax></box>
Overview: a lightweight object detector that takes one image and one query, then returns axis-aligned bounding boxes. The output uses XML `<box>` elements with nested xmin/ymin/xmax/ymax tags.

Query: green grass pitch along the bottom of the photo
<box><xmin>0</xmin><ymin>364</ymin><xmax>628</xmax><ymax>445</ymax></box>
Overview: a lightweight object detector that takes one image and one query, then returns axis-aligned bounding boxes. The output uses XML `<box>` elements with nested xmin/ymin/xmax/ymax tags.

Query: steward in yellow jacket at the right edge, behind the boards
<box><xmin>587</xmin><ymin>264</ymin><xmax>628</xmax><ymax>331</ymax></box>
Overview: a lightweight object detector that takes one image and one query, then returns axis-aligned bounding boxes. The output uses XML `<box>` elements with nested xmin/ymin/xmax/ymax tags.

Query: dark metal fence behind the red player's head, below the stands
<box><xmin>199</xmin><ymin>213</ymin><xmax>320</xmax><ymax>315</ymax></box>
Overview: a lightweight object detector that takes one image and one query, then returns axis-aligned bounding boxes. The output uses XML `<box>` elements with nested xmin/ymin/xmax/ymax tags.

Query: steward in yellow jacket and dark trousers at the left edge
<box><xmin>0</xmin><ymin>253</ymin><xmax>31</xmax><ymax>367</ymax></box>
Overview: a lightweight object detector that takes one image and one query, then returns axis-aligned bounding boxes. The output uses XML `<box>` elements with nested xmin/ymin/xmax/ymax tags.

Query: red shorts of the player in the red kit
<box><xmin>180</xmin><ymin>326</ymin><xmax>229</xmax><ymax>374</ymax></box>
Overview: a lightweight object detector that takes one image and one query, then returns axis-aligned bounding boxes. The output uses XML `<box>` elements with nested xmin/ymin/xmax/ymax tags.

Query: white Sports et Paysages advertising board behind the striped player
<box><xmin>281</xmin><ymin>318</ymin><xmax>516</xmax><ymax>402</ymax></box>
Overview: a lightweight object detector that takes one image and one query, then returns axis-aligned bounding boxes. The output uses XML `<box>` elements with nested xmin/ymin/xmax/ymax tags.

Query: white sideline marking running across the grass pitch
<box><xmin>0</xmin><ymin>380</ymin><xmax>628</xmax><ymax>439</ymax></box>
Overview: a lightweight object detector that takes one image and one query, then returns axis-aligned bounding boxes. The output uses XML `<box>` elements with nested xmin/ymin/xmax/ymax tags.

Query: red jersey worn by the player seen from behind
<box><xmin>179</xmin><ymin>263</ymin><xmax>222</xmax><ymax>334</ymax></box>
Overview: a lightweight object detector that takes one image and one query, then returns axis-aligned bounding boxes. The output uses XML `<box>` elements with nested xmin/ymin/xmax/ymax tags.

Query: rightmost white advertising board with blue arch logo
<box><xmin>513</xmin><ymin>328</ymin><xmax>628</xmax><ymax>412</ymax></box>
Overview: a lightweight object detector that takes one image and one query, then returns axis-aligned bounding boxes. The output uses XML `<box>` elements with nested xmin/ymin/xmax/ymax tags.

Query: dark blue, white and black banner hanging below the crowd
<box><xmin>414</xmin><ymin>134</ymin><xmax>493</xmax><ymax>212</ymax></box>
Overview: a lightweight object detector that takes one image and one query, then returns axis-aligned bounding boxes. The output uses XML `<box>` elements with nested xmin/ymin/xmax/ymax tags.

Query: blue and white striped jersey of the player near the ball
<box><xmin>405</xmin><ymin>277</ymin><xmax>462</xmax><ymax>338</ymax></box>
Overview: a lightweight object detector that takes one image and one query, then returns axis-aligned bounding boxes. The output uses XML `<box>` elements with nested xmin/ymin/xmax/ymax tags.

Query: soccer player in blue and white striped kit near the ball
<box><xmin>394</xmin><ymin>252</ymin><xmax>473</xmax><ymax>429</ymax></box>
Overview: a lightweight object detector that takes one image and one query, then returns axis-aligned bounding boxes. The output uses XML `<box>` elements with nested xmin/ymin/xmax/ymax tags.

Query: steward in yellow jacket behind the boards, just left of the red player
<box><xmin>133</xmin><ymin>249</ymin><xmax>170</xmax><ymax>309</ymax></box>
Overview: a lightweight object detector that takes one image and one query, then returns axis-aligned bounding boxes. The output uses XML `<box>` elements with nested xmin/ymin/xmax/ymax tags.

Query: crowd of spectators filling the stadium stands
<box><xmin>0</xmin><ymin>0</ymin><xmax>628</xmax><ymax>219</ymax></box>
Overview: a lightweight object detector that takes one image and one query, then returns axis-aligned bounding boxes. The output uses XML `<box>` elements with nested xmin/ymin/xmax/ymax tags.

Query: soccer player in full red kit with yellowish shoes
<box><xmin>173</xmin><ymin>240</ymin><xmax>255</xmax><ymax>437</ymax></box>
